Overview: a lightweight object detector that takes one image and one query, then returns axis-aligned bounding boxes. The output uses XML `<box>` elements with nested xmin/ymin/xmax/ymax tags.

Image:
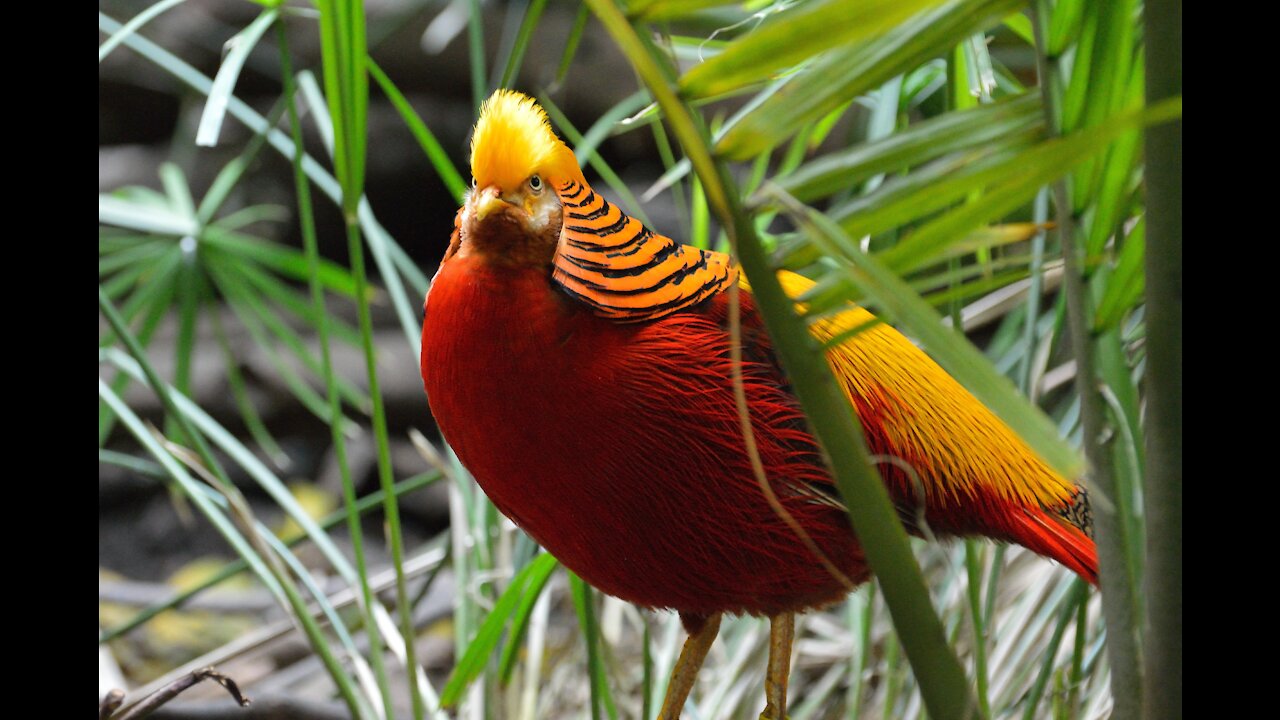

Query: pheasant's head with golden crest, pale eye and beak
<box><xmin>461</xmin><ymin>90</ymin><xmax>582</xmax><ymax>265</ymax></box>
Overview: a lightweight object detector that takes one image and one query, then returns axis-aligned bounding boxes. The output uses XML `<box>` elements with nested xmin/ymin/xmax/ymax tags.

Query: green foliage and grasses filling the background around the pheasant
<box><xmin>99</xmin><ymin>0</ymin><xmax>1181</xmax><ymax>720</ymax></box>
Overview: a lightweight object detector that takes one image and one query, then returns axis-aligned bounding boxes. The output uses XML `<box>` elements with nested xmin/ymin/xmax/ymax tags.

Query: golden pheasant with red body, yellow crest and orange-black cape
<box><xmin>421</xmin><ymin>90</ymin><xmax>1098</xmax><ymax>720</ymax></box>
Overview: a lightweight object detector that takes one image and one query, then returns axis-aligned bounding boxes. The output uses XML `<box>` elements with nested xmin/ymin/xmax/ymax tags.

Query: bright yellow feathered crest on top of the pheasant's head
<box><xmin>471</xmin><ymin>90</ymin><xmax>582</xmax><ymax>191</ymax></box>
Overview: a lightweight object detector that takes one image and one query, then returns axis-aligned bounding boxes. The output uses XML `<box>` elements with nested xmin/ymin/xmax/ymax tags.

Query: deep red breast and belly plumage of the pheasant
<box><xmin>422</xmin><ymin>258</ymin><xmax>867</xmax><ymax>615</ymax></box>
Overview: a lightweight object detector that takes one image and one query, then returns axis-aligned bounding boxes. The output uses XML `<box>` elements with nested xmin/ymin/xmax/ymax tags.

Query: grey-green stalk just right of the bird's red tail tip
<box><xmin>1032</xmin><ymin>0</ymin><xmax>1143</xmax><ymax>720</ymax></box>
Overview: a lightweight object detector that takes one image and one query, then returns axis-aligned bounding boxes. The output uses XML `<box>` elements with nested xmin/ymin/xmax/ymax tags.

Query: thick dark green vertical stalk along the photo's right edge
<box><xmin>1143</xmin><ymin>0</ymin><xmax>1183</xmax><ymax>719</ymax></box>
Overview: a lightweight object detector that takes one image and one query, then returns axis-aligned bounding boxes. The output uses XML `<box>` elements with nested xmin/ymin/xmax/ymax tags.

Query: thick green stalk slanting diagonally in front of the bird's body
<box><xmin>586</xmin><ymin>0</ymin><xmax>977</xmax><ymax>720</ymax></box>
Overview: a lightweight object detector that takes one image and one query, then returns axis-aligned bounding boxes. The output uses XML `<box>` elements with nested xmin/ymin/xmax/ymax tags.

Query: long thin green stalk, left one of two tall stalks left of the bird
<box><xmin>276</xmin><ymin>19</ymin><xmax>394</xmax><ymax>720</ymax></box>
